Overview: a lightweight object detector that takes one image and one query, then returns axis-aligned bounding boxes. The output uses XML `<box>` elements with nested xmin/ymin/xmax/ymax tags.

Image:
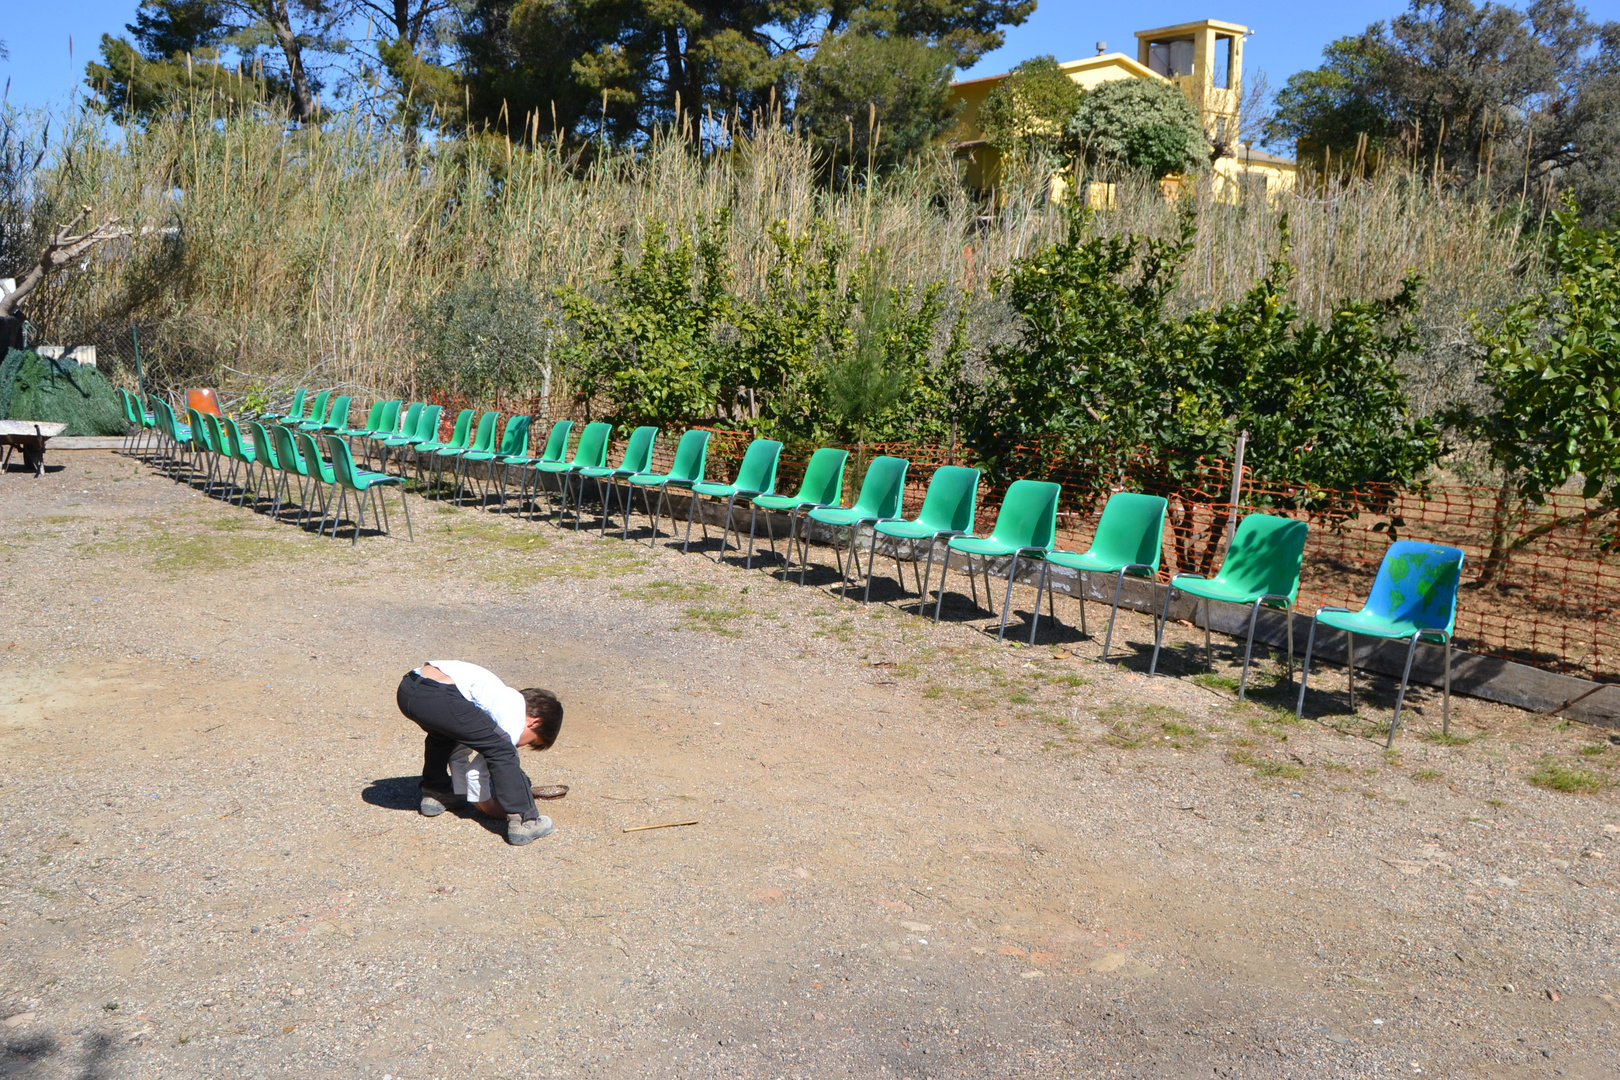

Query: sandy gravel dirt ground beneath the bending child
<box><xmin>0</xmin><ymin>452</ymin><xmax>1620</xmax><ymax>1080</ymax></box>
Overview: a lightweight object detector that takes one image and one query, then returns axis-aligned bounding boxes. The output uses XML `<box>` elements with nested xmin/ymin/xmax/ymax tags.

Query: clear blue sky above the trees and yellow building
<box><xmin>0</xmin><ymin>0</ymin><xmax>1620</xmax><ymax>114</ymax></box>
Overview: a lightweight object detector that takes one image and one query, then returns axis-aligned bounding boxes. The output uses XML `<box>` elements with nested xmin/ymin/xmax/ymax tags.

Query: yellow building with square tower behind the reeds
<box><xmin>951</xmin><ymin>19</ymin><xmax>1298</xmax><ymax>204</ymax></box>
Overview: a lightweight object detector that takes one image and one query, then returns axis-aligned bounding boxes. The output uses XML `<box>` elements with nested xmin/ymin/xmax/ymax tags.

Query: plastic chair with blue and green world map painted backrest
<box><xmin>1294</xmin><ymin>541</ymin><xmax>1463</xmax><ymax>748</ymax></box>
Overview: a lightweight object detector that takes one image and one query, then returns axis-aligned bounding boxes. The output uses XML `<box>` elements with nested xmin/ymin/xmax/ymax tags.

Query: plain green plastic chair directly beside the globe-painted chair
<box><xmin>1147</xmin><ymin>513</ymin><xmax>1309</xmax><ymax>701</ymax></box>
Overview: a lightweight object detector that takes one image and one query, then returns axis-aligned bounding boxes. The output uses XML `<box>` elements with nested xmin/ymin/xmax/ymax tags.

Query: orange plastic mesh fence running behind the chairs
<box><xmin>408</xmin><ymin>395</ymin><xmax>1620</xmax><ymax>680</ymax></box>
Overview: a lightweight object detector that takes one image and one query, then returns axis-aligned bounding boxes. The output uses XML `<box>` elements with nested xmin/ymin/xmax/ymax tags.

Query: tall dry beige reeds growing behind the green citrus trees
<box><xmin>22</xmin><ymin>107</ymin><xmax>1524</xmax><ymax>410</ymax></box>
